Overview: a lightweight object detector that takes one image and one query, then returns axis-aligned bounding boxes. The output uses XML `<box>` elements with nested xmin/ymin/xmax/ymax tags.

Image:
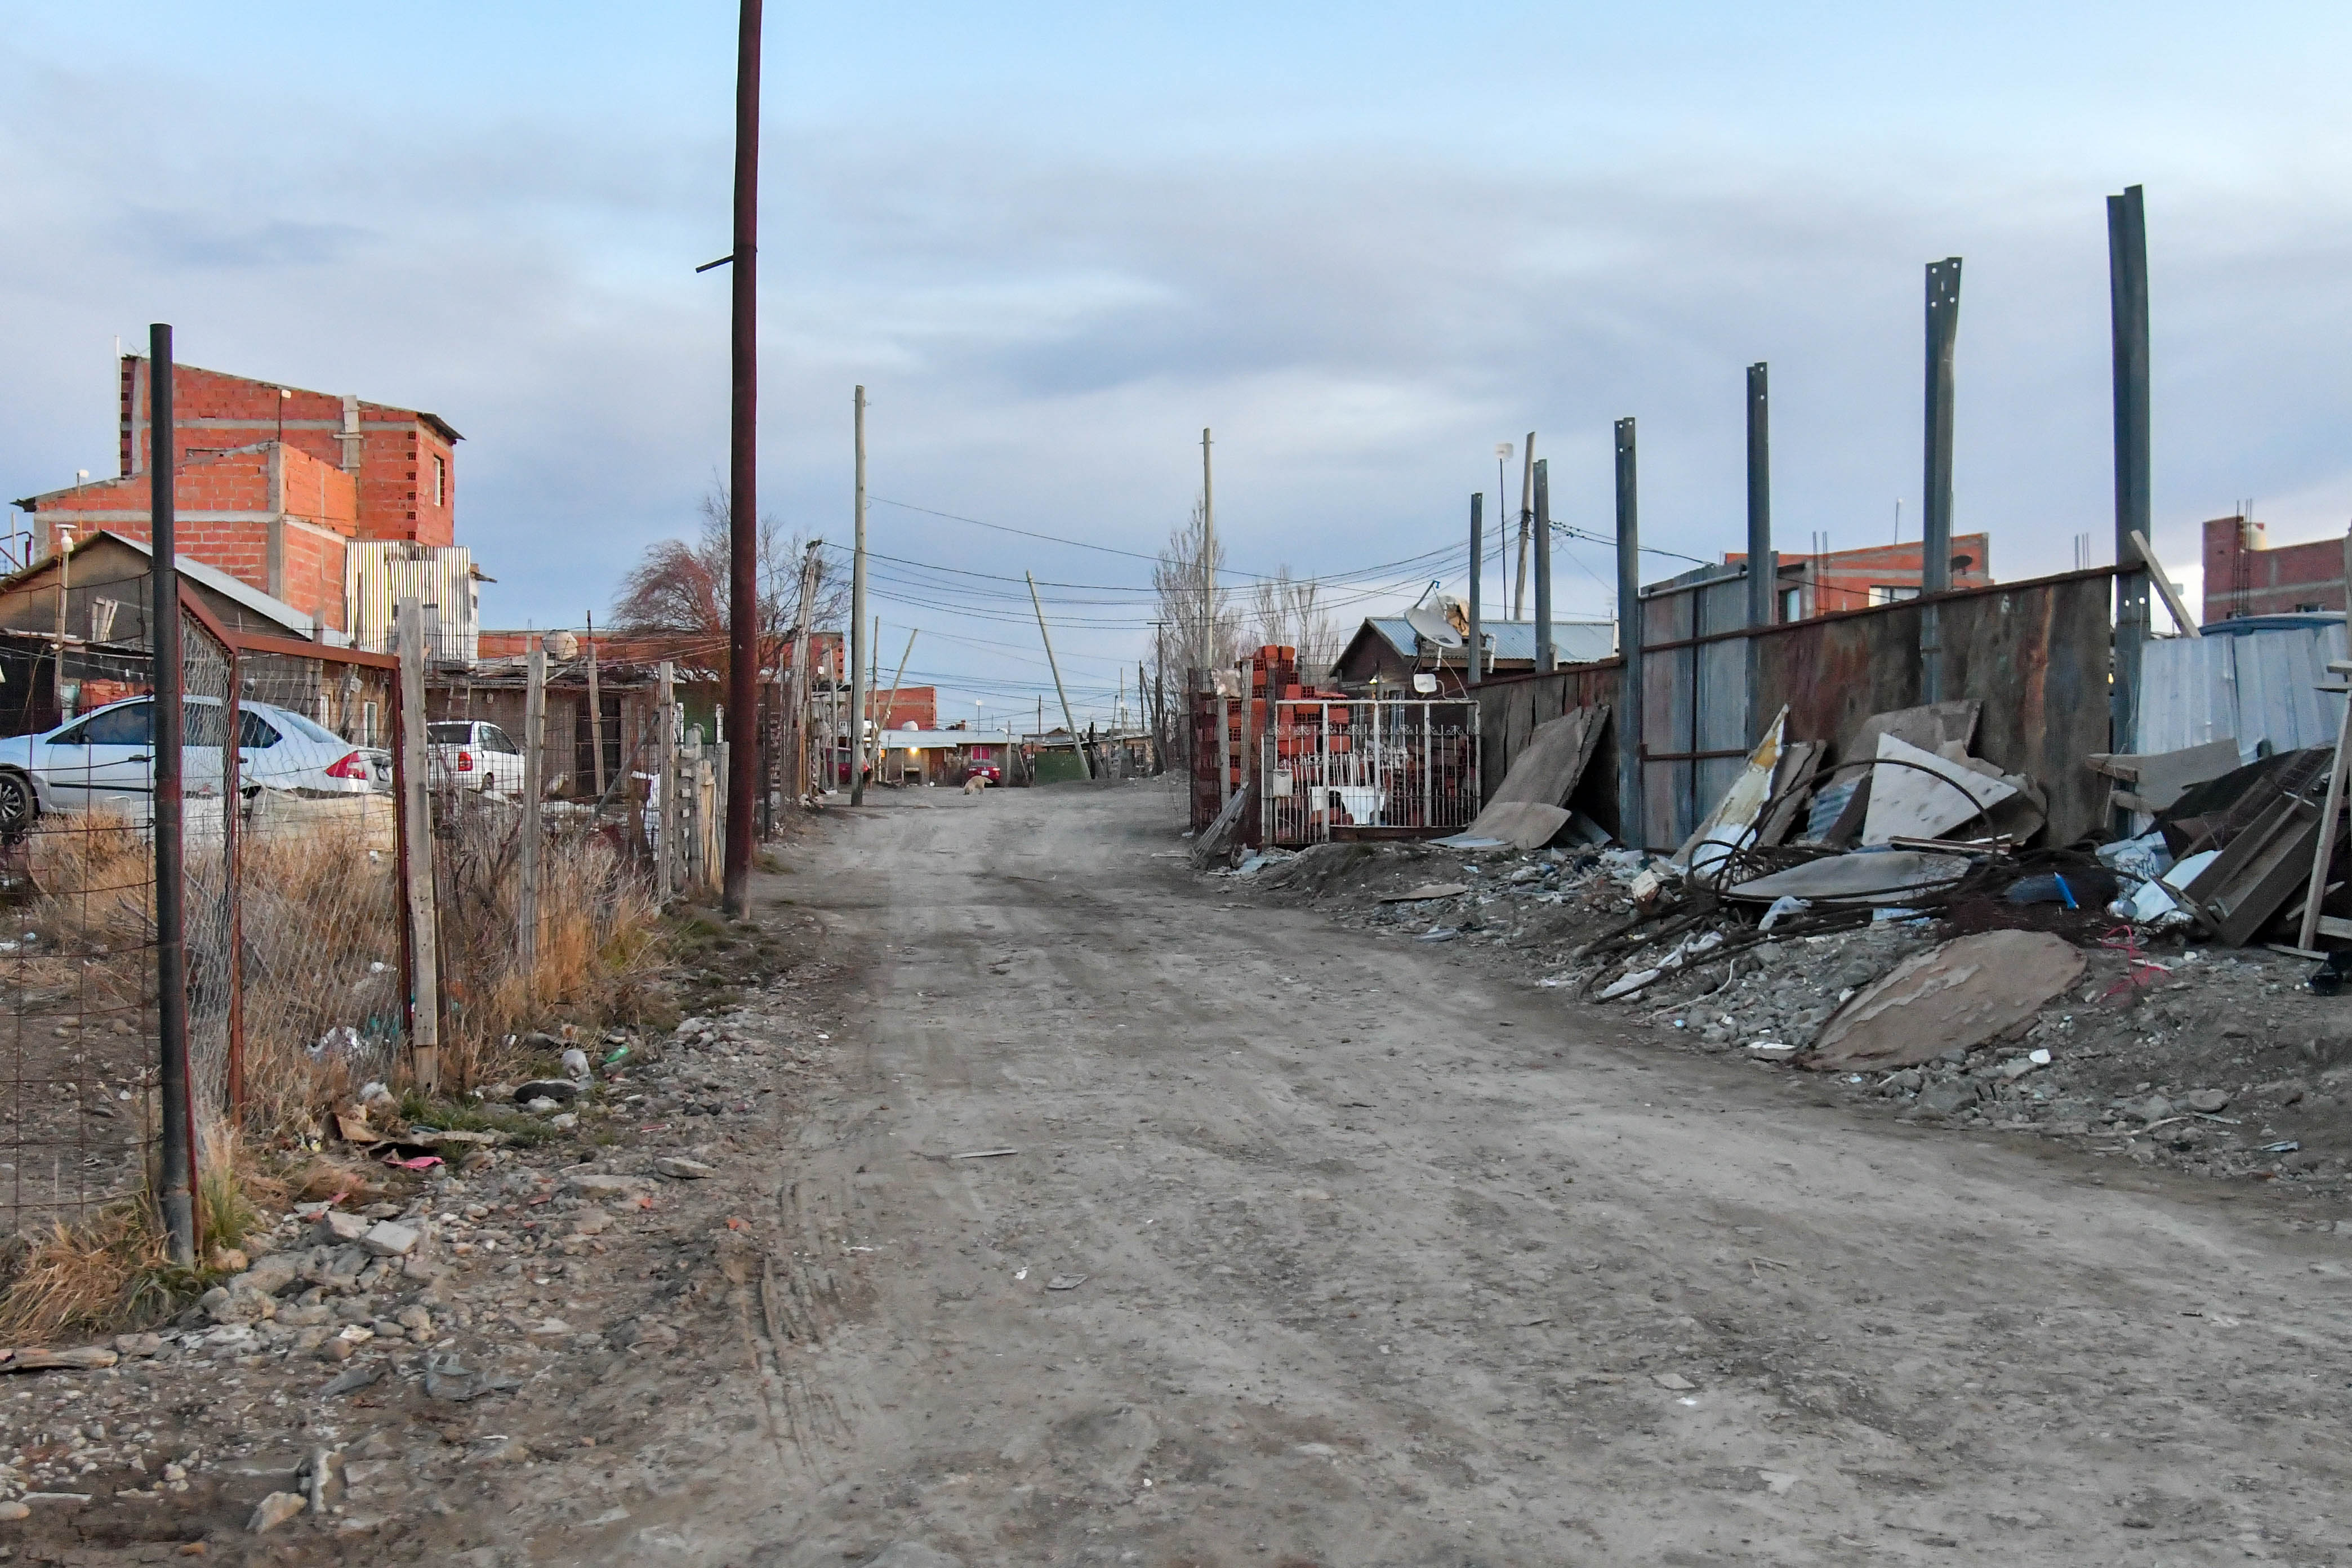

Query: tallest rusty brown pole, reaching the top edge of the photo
<box><xmin>722</xmin><ymin>0</ymin><xmax>760</xmax><ymax>919</ymax></box>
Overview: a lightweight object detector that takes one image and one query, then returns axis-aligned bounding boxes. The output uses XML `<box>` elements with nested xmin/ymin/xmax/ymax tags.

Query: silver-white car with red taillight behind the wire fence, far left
<box><xmin>0</xmin><ymin>696</ymin><xmax>393</xmax><ymax>832</ymax></box>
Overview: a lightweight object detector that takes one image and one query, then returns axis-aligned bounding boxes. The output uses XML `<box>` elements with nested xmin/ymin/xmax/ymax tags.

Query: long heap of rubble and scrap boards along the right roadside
<box><xmin>1226</xmin><ymin>703</ymin><xmax>2352</xmax><ymax>1192</ymax></box>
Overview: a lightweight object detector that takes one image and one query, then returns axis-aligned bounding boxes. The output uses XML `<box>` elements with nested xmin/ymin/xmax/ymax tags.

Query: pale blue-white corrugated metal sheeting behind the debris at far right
<box><xmin>2133</xmin><ymin>616</ymin><xmax>2347</xmax><ymax>761</ymax></box>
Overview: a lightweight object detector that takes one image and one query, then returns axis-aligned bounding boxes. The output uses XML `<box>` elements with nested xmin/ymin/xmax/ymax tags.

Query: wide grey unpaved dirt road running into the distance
<box><xmin>672</xmin><ymin>785</ymin><xmax>2352</xmax><ymax>1568</ymax></box>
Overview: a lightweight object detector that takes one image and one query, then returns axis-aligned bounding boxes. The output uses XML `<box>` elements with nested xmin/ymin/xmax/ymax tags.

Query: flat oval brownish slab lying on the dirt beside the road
<box><xmin>1804</xmin><ymin>931</ymin><xmax>2084</xmax><ymax>1072</ymax></box>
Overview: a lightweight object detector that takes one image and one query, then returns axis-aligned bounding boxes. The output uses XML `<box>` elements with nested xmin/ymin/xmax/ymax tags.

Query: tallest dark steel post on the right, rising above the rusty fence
<box><xmin>2108</xmin><ymin>186</ymin><xmax>2154</xmax><ymax>757</ymax></box>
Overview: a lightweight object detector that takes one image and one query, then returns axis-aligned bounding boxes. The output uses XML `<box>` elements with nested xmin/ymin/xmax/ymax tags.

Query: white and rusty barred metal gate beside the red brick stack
<box><xmin>1260</xmin><ymin>698</ymin><xmax>1480</xmax><ymax>849</ymax></box>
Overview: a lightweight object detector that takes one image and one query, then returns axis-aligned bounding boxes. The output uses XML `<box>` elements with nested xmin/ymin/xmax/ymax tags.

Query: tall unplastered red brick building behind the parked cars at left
<box><xmin>16</xmin><ymin>355</ymin><xmax>461</xmax><ymax>632</ymax></box>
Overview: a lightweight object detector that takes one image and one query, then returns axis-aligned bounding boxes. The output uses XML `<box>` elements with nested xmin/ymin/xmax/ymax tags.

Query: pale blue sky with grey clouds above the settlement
<box><xmin>0</xmin><ymin>0</ymin><xmax>2352</xmax><ymax>721</ymax></box>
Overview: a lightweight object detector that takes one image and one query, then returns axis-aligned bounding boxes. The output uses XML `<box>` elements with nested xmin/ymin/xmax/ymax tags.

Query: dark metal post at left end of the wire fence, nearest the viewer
<box><xmin>148</xmin><ymin>322</ymin><xmax>195</xmax><ymax>1265</ymax></box>
